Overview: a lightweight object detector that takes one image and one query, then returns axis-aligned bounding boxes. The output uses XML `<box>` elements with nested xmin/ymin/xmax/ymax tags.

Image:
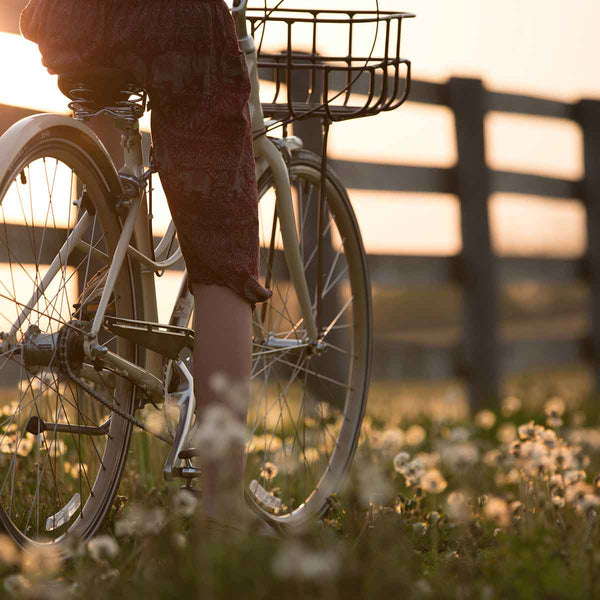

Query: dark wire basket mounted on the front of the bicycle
<box><xmin>246</xmin><ymin>8</ymin><xmax>414</xmax><ymax>122</ymax></box>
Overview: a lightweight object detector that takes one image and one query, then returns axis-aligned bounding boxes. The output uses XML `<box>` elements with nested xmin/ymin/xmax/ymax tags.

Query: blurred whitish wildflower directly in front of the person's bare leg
<box><xmin>192</xmin><ymin>404</ymin><xmax>248</xmax><ymax>459</ymax></box>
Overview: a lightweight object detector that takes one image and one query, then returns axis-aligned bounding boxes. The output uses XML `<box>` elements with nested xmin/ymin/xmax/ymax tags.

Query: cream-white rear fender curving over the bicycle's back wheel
<box><xmin>0</xmin><ymin>114</ymin><xmax>122</xmax><ymax>201</ymax></box>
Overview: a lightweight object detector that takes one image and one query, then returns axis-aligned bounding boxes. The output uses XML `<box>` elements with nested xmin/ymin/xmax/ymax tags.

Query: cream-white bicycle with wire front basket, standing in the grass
<box><xmin>0</xmin><ymin>0</ymin><xmax>412</xmax><ymax>549</ymax></box>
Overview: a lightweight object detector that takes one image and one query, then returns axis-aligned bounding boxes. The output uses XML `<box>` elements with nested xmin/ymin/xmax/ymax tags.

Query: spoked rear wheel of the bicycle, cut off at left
<box><xmin>0</xmin><ymin>129</ymin><xmax>136</xmax><ymax>549</ymax></box>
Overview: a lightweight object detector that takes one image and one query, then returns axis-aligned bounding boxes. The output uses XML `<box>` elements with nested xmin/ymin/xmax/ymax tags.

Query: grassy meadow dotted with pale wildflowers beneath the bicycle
<box><xmin>0</xmin><ymin>370</ymin><xmax>600</xmax><ymax>600</ymax></box>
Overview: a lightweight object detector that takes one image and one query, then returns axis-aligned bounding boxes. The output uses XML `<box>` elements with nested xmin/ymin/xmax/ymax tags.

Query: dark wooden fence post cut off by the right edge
<box><xmin>576</xmin><ymin>100</ymin><xmax>600</xmax><ymax>389</ymax></box>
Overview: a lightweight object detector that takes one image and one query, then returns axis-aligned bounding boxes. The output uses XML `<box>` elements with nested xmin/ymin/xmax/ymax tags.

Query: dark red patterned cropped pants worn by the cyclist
<box><xmin>21</xmin><ymin>0</ymin><xmax>271</xmax><ymax>308</ymax></box>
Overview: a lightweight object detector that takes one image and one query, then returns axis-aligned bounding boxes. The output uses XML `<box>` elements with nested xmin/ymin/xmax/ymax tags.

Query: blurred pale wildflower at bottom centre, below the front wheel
<box><xmin>272</xmin><ymin>541</ymin><xmax>341</xmax><ymax>581</ymax></box>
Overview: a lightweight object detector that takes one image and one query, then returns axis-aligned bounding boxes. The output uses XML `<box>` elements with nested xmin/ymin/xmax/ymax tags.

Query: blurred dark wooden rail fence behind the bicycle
<box><xmin>0</xmin><ymin>50</ymin><xmax>600</xmax><ymax>409</ymax></box>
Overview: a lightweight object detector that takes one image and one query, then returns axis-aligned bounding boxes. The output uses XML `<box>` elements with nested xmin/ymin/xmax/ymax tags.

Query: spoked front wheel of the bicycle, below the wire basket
<box><xmin>245</xmin><ymin>151</ymin><xmax>371</xmax><ymax>528</ymax></box>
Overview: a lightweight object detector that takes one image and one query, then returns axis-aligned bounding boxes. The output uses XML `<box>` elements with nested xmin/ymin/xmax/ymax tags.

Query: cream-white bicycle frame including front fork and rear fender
<box><xmin>0</xmin><ymin>0</ymin><xmax>318</xmax><ymax>402</ymax></box>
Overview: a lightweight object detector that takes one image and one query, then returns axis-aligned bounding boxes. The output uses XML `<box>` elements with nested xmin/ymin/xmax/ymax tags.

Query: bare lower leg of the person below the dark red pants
<box><xmin>193</xmin><ymin>284</ymin><xmax>252</xmax><ymax>518</ymax></box>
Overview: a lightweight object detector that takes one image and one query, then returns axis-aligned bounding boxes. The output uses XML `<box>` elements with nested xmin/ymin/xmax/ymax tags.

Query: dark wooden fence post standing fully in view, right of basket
<box><xmin>448</xmin><ymin>78</ymin><xmax>499</xmax><ymax>411</ymax></box>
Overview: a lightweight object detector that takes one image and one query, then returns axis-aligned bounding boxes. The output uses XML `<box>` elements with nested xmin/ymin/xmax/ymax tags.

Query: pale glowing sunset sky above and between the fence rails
<box><xmin>0</xmin><ymin>0</ymin><xmax>600</xmax><ymax>266</ymax></box>
